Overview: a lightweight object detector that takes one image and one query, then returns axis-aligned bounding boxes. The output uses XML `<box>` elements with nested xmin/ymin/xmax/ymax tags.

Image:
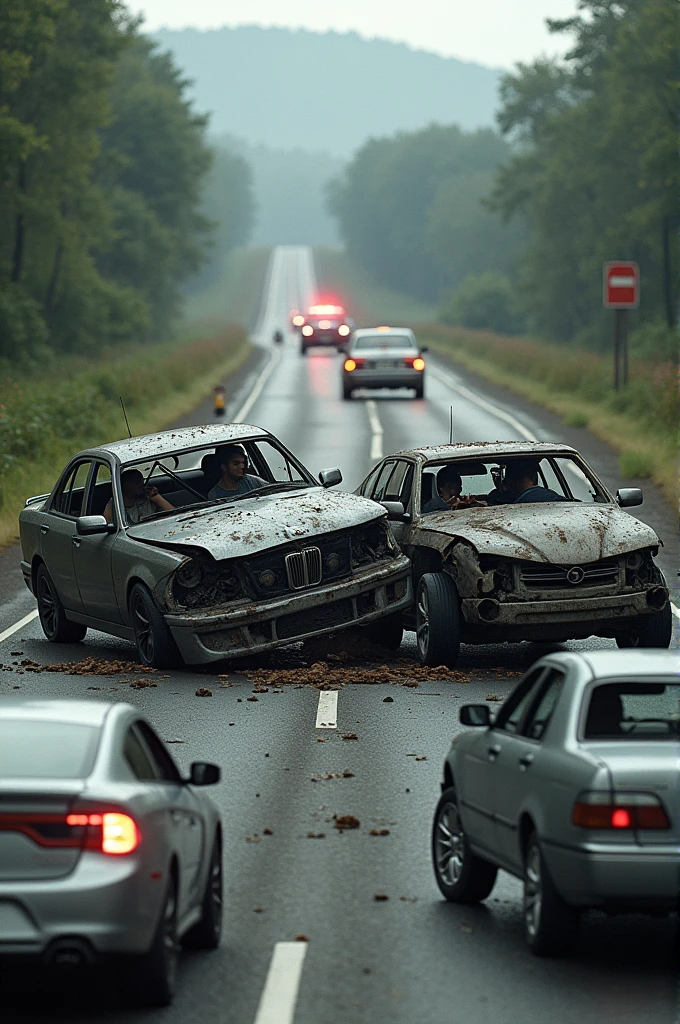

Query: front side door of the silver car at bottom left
<box><xmin>137</xmin><ymin>721</ymin><xmax>206</xmax><ymax>908</ymax></box>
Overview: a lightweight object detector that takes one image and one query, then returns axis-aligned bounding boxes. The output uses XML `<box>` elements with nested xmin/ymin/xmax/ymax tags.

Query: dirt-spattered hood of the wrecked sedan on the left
<box><xmin>128</xmin><ymin>487</ymin><xmax>385</xmax><ymax>561</ymax></box>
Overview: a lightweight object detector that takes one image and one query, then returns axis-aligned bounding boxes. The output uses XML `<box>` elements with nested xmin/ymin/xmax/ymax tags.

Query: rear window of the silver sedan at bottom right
<box><xmin>585</xmin><ymin>682</ymin><xmax>680</xmax><ymax>742</ymax></box>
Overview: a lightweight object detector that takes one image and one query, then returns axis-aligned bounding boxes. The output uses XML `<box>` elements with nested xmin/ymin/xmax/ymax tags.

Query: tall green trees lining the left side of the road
<box><xmin>0</xmin><ymin>0</ymin><xmax>252</xmax><ymax>362</ymax></box>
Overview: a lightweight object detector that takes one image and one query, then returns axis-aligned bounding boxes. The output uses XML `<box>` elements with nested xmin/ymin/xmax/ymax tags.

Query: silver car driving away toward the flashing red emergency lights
<box><xmin>342</xmin><ymin>327</ymin><xmax>427</xmax><ymax>398</ymax></box>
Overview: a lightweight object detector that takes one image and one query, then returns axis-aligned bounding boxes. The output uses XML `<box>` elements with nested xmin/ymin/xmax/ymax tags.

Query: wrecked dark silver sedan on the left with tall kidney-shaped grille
<box><xmin>19</xmin><ymin>424</ymin><xmax>411</xmax><ymax>668</ymax></box>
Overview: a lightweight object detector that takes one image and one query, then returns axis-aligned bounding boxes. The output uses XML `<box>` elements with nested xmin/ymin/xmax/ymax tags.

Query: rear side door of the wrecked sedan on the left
<box><xmin>40</xmin><ymin>459</ymin><xmax>92</xmax><ymax>612</ymax></box>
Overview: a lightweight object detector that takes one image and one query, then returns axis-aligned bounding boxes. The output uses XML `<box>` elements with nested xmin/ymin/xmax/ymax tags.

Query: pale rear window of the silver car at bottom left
<box><xmin>0</xmin><ymin>718</ymin><xmax>99</xmax><ymax>778</ymax></box>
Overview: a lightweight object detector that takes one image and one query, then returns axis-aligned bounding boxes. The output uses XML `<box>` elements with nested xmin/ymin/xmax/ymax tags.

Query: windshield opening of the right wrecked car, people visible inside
<box><xmin>421</xmin><ymin>451</ymin><xmax>611</xmax><ymax>513</ymax></box>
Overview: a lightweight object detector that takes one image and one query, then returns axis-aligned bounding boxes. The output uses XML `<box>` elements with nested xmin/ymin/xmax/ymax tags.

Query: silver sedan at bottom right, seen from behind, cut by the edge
<box><xmin>432</xmin><ymin>650</ymin><xmax>680</xmax><ymax>955</ymax></box>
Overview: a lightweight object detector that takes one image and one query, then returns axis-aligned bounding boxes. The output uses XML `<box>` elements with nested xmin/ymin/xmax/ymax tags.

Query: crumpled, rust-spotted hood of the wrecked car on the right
<box><xmin>414</xmin><ymin>502</ymin><xmax>661</xmax><ymax>565</ymax></box>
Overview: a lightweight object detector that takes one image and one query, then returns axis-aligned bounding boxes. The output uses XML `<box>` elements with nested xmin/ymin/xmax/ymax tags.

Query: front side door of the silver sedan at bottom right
<box><xmin>456</xmin><ymin>666</ymin><xmax>545</xmax><ymax>856</ymax></box>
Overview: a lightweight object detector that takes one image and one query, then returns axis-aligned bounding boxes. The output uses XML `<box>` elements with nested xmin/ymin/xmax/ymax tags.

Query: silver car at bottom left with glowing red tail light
<box><xmin>0</xmin><ymin>697</ymin><xmax>222</xmax><ymax>1006</ymax></box>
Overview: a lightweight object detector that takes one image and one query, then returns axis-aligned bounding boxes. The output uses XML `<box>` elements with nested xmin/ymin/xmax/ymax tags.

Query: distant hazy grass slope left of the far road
<box><xmin>183</xmin><ymin>246</ymin><xmax>271</xmax><ymax>332</ymax></box>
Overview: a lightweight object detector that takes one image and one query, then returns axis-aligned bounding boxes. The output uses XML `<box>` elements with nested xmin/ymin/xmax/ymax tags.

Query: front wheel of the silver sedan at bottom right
<box><xmin>432</xmin><ymin>786</ymin><xmax>498</xmax><ymax>903</ymax></box>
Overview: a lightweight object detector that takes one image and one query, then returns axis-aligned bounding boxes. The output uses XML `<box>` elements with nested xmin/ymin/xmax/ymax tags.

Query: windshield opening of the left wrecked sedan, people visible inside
<box><xmin>121</xmin><ymin>437</ymin><xmax>318</xmax><ymax>522</ymax></box>
